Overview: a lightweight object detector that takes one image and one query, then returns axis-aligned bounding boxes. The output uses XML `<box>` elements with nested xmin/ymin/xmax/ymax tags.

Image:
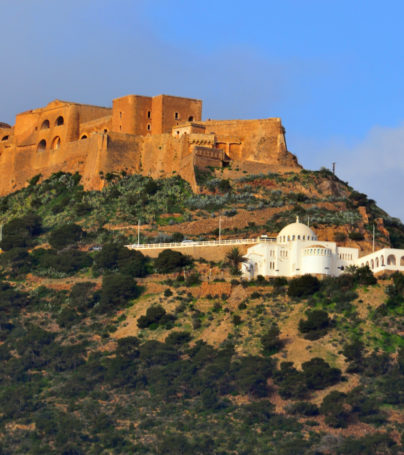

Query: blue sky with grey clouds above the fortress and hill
<box><xmin>0</xmin><ymin>0</ymin><xmax>404</xmax><ymax>220</ymax></box>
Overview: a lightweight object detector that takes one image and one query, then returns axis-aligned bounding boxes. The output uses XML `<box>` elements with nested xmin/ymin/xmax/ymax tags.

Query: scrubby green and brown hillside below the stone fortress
<box><xmin>0</xmin><ymin>172</ymin><xmax>404</xmax><ymax>455</ymax></box>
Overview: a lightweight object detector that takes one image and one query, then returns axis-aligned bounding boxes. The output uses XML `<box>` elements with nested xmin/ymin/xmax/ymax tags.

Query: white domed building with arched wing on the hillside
<box><xmin>241</xmin><ymin>218</ymin><xmax>404</xmax><ymax>279</ymax></box>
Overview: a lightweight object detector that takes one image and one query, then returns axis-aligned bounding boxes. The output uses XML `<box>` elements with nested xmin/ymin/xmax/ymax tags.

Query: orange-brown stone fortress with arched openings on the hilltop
<box><xmin>0</xmin><ymin>95</ymin><xmax>300</xmax><ymax>195</ymax></box>
